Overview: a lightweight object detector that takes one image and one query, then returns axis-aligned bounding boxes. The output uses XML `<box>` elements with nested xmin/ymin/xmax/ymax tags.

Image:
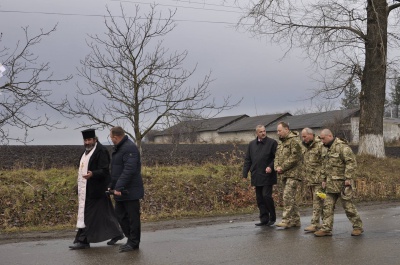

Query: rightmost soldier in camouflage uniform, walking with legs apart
<box><xmin>314</xmin><ymin>129</ymin><xmax>364</xmax><ymax>237</ymax></box>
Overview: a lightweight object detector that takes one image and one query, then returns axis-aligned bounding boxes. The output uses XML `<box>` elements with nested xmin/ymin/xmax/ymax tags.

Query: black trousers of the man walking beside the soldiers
<box><xmin>256</xmin><ymin>185</ymin><xmax>276</xmax><ymax>222</ymax></box>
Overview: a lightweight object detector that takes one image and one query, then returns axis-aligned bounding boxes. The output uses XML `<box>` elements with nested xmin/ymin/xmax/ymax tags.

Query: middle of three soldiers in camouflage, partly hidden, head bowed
<box><xmin>301</xmin><ymin>128</ymin><xmax>324</xmax><ymax>232</ymax></box>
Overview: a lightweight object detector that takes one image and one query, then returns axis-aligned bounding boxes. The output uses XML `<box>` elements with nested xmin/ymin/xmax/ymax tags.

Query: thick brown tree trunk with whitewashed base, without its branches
<box><xmin>358</xmin><ymin>0</ymin><xmax>388</xmax><ymax>157</ymax></box>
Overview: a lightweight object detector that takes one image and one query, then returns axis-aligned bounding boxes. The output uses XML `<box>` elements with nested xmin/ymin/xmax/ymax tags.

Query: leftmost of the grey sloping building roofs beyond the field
<box><xmin>156</xmin><ymin>114</ymin><xmax>248</xmax><ymax>136</ymax></box>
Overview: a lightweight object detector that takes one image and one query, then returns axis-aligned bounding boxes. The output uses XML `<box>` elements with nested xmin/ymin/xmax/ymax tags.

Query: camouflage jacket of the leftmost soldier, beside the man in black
<box><xmin>274</xmin><ymin>131</ymin><xmax>302</xmax><ymax>180</ymax></box>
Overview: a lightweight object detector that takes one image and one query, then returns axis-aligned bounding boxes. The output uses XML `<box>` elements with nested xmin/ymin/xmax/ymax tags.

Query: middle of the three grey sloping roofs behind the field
<box><xmin>218</xmin><ymin>112</ymin><xmax>291</xmax><ymax>133</ymax></box>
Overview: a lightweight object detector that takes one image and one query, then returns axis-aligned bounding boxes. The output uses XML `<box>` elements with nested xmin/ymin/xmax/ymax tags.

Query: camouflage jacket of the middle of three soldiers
<box><xmin>301</xmin><ymin>136</ymin><xmax>323</xmax><ymax>185</ymax></box>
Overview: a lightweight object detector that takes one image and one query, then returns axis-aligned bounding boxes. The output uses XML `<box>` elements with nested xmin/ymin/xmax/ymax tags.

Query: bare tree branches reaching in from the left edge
<box><xmin>0</xmin><ymin>26</ymin><xmax>72</xmax><ymax>144</ymax></box>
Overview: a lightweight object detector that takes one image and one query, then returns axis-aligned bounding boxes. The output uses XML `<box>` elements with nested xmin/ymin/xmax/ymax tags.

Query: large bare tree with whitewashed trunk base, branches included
<box><xmin>234</xmin><ymin>0</ymin><xmax>400</xmax><ymax>157</ymax></box>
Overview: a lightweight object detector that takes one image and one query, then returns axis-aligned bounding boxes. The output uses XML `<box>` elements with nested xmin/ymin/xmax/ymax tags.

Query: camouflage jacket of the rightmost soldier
<box><xmin>321</xmin><ymin>138</ymin><xmax>357</xmax><ymax>193</ymax></box>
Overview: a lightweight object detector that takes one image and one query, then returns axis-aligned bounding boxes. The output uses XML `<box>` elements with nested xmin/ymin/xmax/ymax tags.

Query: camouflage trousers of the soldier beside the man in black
<box><xmin>282</xmin><ymin>178</ymin><xmax>300</xmax><ymax>224</ymax></box>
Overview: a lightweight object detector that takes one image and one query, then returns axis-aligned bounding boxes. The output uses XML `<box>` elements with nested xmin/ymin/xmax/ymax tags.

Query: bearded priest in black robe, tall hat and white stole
<box><xmin>69</xmin><ymin>129</ymin><xmax>124</xmax><ymax>250</ymax></box>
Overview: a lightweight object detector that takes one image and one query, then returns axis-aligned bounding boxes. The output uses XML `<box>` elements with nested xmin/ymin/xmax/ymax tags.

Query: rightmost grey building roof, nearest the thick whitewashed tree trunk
<box><xmin>265</xmin><ymin>109</ymin><xmax>360</xmax><ymax>132</ymax></box>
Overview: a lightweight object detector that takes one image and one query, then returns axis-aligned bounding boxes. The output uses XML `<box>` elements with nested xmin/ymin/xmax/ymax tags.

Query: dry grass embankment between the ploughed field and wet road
<box><xmin>0</xmin><ymin>157</ymin><xmax>400</xmax><ymax>232</ymax></box>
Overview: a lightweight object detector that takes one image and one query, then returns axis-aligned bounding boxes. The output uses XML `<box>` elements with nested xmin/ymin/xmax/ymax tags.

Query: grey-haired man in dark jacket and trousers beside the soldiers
<box><xmin>243</xmin><ymin>125</ymin><xmax>278</xmax><ymax>226</ymax></box>
